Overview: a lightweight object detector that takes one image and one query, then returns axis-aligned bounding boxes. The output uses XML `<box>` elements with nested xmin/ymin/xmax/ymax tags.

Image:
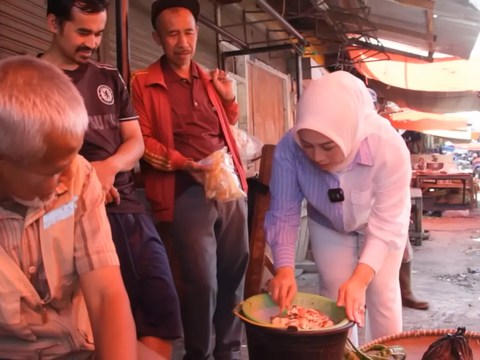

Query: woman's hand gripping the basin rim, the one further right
<box><xmin>337</xmin><ymin>264</ymin><xmax>375</xmax><ymax>327</ymax></box>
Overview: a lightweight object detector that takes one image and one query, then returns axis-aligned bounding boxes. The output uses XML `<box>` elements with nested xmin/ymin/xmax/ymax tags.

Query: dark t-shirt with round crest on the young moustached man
<box><xmin>65</xmin><ymin>61</ymin><xmax>145</xmax><ymax>214</ymax></box>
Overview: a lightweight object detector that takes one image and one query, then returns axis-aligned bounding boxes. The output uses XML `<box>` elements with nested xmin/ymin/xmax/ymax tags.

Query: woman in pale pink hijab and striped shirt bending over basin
<box><xmin>265</xmin><ymin>71</ymin><xmax>412</xmax><ymax>343</ymax></box>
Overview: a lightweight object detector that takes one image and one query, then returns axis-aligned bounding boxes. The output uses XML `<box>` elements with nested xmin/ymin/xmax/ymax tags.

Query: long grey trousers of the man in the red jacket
<box><xmin>171</xmin><ymin>185</ymin><xmax>249</xmax><ymax>360</ymax></box>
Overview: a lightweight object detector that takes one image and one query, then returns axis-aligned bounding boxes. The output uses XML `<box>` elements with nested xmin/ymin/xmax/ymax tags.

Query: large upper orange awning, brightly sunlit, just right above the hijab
<box><xmin>350</xmin><ymin>50</ymin><xmax>480</xmax><ymax>92</ymax></box>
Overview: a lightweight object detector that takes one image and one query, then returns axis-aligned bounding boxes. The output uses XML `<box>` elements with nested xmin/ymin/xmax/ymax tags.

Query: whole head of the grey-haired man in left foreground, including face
<box><xmin>0</xmin><ymin>56</ymin><xmax>88</xmax><ymax>204</ymax></box>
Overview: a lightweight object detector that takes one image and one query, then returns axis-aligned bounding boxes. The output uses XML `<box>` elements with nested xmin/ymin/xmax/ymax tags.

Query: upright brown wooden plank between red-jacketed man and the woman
<box><xmin>245</xmin><ymin>145</ymin><xmax>275</xmax><ymax>298</ymax></box>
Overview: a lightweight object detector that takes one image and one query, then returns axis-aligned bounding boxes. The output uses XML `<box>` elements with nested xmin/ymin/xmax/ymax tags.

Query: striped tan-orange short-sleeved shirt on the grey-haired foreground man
<box><xmin>0</xmin><ymin>156</ymin><xmax>119</xmax><ymax>359</ymax></box>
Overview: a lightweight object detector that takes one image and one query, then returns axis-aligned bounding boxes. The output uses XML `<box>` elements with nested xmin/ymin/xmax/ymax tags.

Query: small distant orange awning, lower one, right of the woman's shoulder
<box><xmin>384</xmin><ymin>111</ymin><xmax>467</xmax><ymax>132</ymax></box>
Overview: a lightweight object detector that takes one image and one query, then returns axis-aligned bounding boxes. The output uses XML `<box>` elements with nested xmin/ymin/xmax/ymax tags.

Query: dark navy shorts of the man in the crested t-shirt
<box><xmin>108</xmin><ymin>213</ymin><xmax>183</xmax><ymax>340</ymax></box>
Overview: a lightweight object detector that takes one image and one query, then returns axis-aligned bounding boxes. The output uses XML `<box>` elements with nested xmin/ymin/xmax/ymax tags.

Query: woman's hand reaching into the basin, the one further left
<box><xmin>269</xmin><ymin>266</ymin><xmax>297</xmax><ymax>311</ymax></box>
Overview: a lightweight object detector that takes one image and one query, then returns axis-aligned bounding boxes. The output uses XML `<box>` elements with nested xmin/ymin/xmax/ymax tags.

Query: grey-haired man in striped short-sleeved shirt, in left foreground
<box><xmin>0</xmin><ymin>57</ymin><xmax>163</xmax><ymax>360</ymax></box>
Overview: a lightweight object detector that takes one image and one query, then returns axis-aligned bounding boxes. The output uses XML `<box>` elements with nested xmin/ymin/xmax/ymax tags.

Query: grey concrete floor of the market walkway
<box><xmin>174</xmin><ymin>214</ymin><xmax>480</xmax><ymax>360</ymax></box>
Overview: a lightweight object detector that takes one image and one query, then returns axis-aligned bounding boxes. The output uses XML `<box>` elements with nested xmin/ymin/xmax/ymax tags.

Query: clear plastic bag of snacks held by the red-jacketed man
<box><xmin>199</xmin><ymin>148</ymin><xmax>247</xmax><ymax>201</ymax></box>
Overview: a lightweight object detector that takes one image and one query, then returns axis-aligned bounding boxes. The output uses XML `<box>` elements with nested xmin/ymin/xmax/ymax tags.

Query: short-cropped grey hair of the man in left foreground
<box><xmin>0</xmin><ymin>56</ymin><xmax>88</xmax><ymax>162</ymax></box>
